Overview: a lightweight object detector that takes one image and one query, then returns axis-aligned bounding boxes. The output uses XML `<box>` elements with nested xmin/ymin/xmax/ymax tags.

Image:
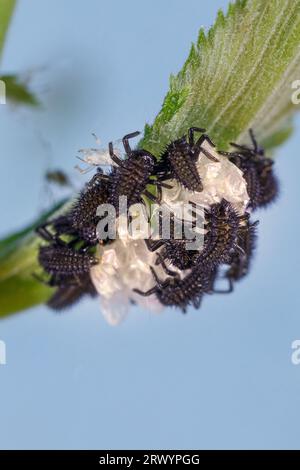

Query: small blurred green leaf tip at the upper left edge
<box><xmin>0</xmin><ymin>75</ymin><xmax>40</xmax><ymax>106</ymax></box>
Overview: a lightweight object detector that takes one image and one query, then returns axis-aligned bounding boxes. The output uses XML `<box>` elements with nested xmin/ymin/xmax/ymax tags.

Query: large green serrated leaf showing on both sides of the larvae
<box><xmin>0</xmin><ymin>0</ymin><xmax>300</xmax><ymax>315</ymax></box>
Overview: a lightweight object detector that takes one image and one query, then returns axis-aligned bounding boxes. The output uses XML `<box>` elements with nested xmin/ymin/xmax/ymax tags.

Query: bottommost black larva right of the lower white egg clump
<box><xmin>134</xmin><ymin>260</ymin><xmax>216</xmax><ymax>313</ymax></box>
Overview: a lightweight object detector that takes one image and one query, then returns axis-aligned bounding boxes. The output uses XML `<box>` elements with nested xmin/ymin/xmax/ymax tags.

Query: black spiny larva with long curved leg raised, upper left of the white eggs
<box><xmin>108</xmin><ymin>132</ymin><xmax>170</xmax><ymax>215</ymax></box>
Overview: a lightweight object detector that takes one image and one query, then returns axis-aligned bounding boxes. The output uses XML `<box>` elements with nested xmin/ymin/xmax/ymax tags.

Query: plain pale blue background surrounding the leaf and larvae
<box><xmin>0</xmin><ymin>0</ymin><xmax>300</xmax><ymax>449</ymax></box>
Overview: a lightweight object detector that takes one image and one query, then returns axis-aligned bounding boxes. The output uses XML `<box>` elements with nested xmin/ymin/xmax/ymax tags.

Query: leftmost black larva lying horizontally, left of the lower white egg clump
<box><xmin>35</xmin><ymin>227</ymin><xmax>98</xmax><ymax>287</ymax></box>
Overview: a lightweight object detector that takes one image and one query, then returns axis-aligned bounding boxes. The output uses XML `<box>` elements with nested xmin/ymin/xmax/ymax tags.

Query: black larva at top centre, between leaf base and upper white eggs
<box><xmin>156</xmin><ymin>127</ymin><xmax>219</xmax><ymax>192</ymax></box>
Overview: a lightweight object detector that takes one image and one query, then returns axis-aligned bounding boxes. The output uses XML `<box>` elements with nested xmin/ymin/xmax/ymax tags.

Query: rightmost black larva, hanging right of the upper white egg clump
<box><xmin>220</xmin><ymin>129</ymin><xmax>279</xmax><ymax>210</ymax></box>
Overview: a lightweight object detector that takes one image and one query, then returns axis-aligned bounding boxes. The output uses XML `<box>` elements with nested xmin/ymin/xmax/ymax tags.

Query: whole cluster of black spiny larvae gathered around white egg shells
<box><xmin>35</xmin><ymin>127</ymin><xmax>278</xmax><ymax>312</ymax></box>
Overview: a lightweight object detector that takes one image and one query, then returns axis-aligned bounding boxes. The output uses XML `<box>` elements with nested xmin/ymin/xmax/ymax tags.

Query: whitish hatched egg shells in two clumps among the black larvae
<box><xmin>91</xmin><ymin>141</ymin><xmax>249</xmax><ymax>325</ymax></box>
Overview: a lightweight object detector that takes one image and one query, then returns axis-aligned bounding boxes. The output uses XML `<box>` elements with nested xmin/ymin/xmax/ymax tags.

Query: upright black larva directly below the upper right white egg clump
<box><xmin>194</xmin><ymin>199</ymin><xmax>249</xmax><ymax>269</ymax></box>
